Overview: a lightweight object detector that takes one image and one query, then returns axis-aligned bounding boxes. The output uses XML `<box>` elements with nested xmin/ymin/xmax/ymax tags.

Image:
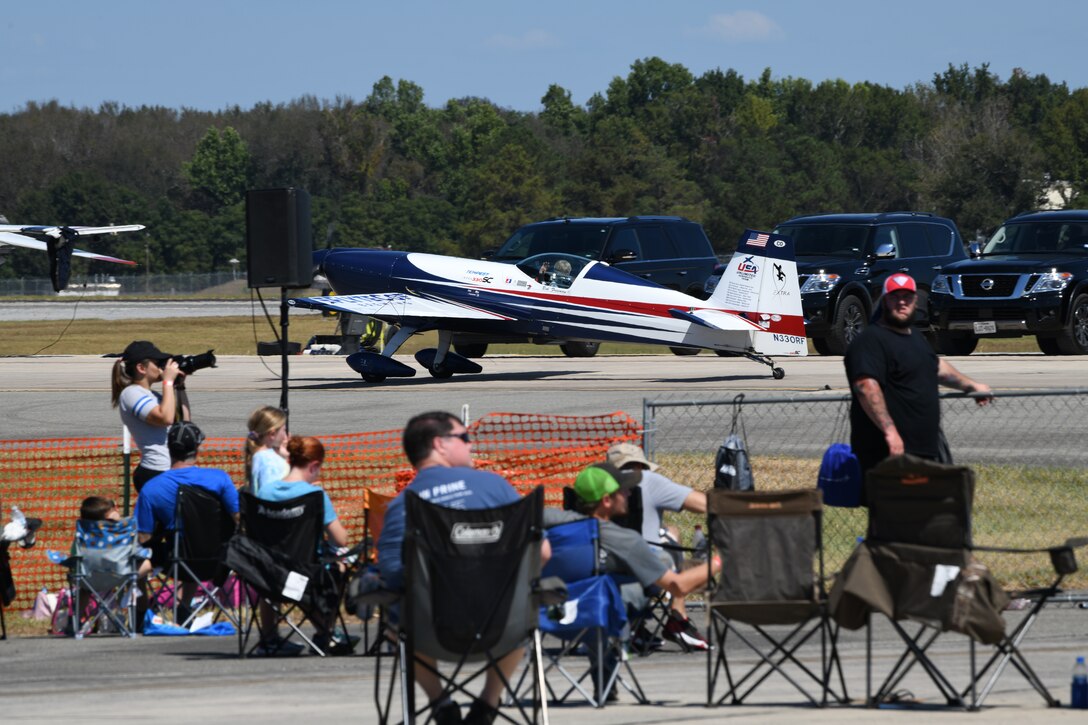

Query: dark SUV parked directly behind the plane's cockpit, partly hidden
<box><xmin>454</xmin><ymin>217</ymin><xmax>718</xmax><ymax>357</ymax></box>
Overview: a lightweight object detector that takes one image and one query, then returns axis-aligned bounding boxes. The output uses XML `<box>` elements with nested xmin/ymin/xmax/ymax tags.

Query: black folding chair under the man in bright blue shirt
<box><xmin>151</xmin><ymin>486</ymin><xmax>239</xmax><ymax>627</ymax></box>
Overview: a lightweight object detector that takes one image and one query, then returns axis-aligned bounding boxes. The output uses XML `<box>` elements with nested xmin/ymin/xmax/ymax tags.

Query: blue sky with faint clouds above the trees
<box><xmin>0</xmin><ymin>0</ymin><xmax>1088</xmax><ymax>112</ymax></box>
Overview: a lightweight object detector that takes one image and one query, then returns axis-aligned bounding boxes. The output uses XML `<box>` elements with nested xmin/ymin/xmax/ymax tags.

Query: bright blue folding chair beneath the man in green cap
<box><xmin>540</xmin><ymin>518</ymin><xmax>647</xmax><ymax>708</ymax></box>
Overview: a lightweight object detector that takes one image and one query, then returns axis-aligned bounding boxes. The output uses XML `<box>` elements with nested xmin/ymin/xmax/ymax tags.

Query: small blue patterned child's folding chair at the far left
<box><xmin>48</xmin><ymin>517</ymin><xmax>145</xmax><ymax>639</ymax></box>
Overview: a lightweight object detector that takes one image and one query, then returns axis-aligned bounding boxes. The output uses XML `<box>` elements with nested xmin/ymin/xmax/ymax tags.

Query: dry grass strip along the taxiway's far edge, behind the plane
<box><xmin>0</xmin><ymin>313</ymin><xmax>1038</xmax><ymax>355</ymax></box>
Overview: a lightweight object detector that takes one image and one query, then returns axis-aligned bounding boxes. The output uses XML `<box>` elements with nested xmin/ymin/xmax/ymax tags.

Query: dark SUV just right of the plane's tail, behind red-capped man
<box><xmin>775</xmin><ymin>211</ymin><xmax>967</xmax><ymax>355</ymax></box>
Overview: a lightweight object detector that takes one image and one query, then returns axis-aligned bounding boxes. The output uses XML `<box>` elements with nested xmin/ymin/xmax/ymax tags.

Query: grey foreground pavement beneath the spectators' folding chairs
<box><xmin>0</xmin><ymin>606</ymin><xmax>1088</xmax><ymax>725</ymax></box>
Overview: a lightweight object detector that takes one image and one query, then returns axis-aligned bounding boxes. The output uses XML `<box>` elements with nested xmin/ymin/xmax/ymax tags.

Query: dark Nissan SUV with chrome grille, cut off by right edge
<box><xmin>930</xmin><ymin>209</ymin><xmax>1088</xmax><ymax>355</ymax></box>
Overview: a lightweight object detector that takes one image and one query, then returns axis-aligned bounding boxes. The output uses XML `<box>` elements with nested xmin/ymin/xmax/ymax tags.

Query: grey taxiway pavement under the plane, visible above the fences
<box><xmin>0</xmin><ymin>355</ymin><xmax>1085</xmax><ymax>439</ymax></box>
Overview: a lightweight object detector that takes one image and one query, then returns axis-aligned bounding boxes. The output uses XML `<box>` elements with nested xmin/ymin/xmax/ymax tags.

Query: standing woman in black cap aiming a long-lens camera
<box><xmin>112</xmin><ymin>340</ymin><xmax>190</xmax><ymax>492</ymax></box>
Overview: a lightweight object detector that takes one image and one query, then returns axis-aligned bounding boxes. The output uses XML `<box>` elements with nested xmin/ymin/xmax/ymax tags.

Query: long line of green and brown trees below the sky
<box><xmin>0</xmin><ymin>58</ymin><xmax>1088</xmax><ymax>277</ymax></box>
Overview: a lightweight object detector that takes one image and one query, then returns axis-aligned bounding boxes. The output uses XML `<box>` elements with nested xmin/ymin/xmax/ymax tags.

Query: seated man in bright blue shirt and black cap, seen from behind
<box><xmin>136</xmin><ymin>420</ymin><xmax>238</xmax><ymax>620</ymax></box>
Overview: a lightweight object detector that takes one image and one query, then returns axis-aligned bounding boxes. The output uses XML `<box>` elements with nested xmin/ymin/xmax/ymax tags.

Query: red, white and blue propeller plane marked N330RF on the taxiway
<box><xmin>288</xmin><ymin>230</ymin><xmax>807</xmax><ymax>382</ymax></box>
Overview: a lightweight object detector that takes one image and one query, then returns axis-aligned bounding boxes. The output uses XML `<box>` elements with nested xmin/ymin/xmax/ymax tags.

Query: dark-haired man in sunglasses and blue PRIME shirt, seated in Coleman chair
<box><xmin>378</xmin><ymin>411</ymin><xmax>549</xmax><ymax>725</ymax></box>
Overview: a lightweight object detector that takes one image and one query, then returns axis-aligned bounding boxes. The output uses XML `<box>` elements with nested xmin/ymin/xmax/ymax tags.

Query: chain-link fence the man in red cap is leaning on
<box><xmin>643</xmin><ymin>390</ymin><xmax>1088</xmax><ymax>589</ymax></box>
